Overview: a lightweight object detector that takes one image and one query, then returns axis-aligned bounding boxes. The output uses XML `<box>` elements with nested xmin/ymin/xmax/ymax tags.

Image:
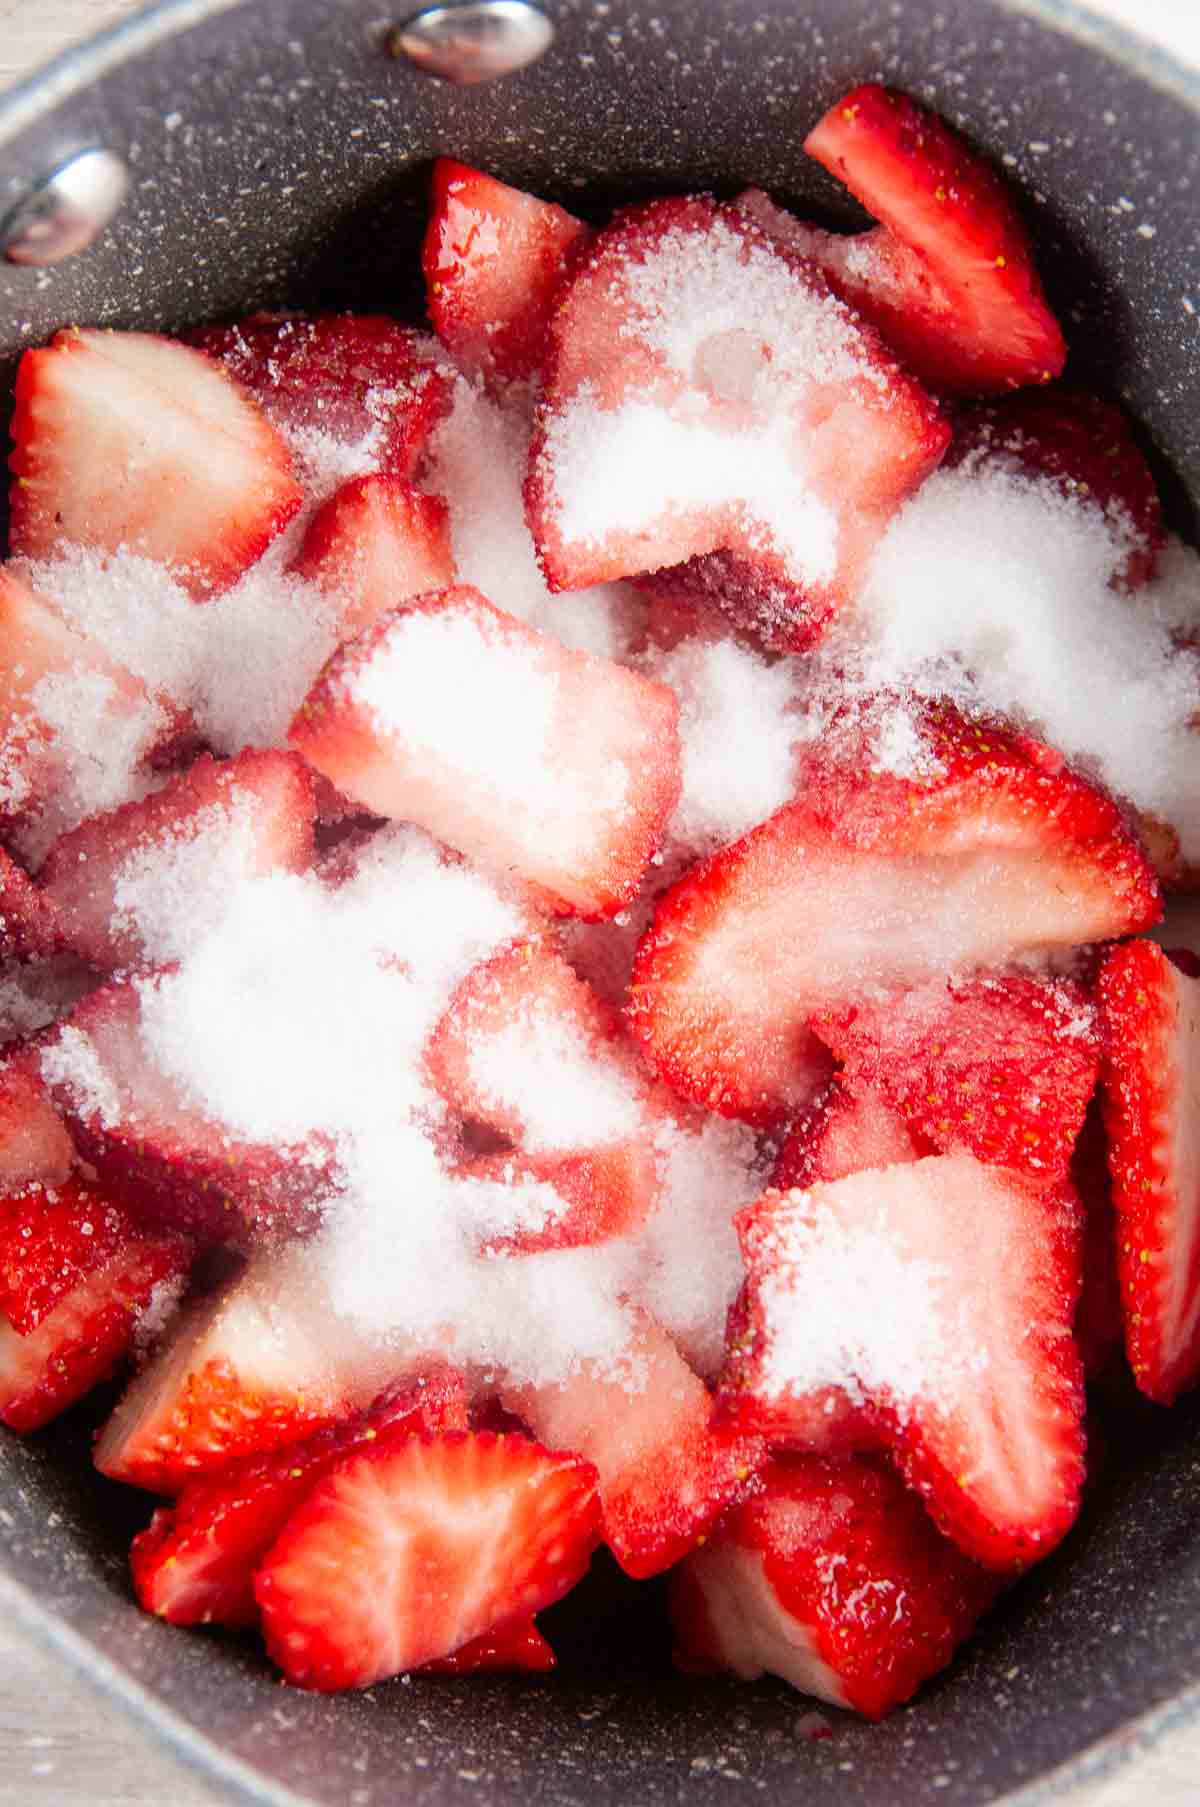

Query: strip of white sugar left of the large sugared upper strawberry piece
<box><xmin>425</xmin><ymin>378</ymin><xmax>645</xmax><ymax>660</ymax></box>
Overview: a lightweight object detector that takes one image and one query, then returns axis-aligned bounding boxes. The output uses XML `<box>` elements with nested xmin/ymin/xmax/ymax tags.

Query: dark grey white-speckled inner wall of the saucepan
<box><xmin>0</xmin><ymin>0</ymin><xmax>1200</xmax><ymax>1807</ymax></box>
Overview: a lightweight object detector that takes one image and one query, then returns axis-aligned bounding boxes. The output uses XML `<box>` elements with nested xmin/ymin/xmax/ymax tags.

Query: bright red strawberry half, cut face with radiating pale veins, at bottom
<box><xmin>255</xmin><ymin>1431</ymin><xmax>598</xmax><ymax>1693</ymax></box>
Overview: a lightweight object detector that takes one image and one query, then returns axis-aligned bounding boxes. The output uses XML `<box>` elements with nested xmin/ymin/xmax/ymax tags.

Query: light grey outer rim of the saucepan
<box><xmin>0</xmin><ymin>0</ymin><xmax>1200</xmax><ymax>1807</ymax></box>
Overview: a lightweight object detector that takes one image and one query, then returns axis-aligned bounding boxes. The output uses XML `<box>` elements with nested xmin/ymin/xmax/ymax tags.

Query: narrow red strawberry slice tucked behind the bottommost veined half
<box><xmin>130</xmin><ymin>1370</ymin><xmax>466</xmax><ymax>1624</ymax></box>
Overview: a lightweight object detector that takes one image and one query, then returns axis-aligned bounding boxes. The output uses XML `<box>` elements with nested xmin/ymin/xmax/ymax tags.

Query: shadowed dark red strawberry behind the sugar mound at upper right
<box><xmin>947</xmin><ymin>387</ymin><xmax>1166</xmax><ymax>589</ymax></box>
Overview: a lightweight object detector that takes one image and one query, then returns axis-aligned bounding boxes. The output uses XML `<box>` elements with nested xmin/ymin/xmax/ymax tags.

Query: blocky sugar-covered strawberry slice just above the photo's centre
<box><xmin>289</xmin><ymin>587</ymin><xmax>680</xmax><ymax>918</ymax></box>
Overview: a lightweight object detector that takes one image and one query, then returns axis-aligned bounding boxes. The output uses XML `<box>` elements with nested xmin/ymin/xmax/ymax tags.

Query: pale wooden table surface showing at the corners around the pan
<box><xmin>0</xmin><ymin>0</ymin><xmax>1200</xmax><ymax>1807</ymax></box>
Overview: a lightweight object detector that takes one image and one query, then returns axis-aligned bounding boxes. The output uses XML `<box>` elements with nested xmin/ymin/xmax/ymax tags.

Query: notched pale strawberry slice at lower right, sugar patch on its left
<box><xmin>721</xmin><ymin>1155</ymin><xmax>1084</xmax><ymax>1570</ymax></box>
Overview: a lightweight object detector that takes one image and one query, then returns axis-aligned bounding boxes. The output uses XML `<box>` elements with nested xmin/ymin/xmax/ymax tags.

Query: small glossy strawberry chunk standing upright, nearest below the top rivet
<box><xmin>421</xmin><ymin>157</ymin><xmax>587</xmax><ymax>379</ymax></box>
